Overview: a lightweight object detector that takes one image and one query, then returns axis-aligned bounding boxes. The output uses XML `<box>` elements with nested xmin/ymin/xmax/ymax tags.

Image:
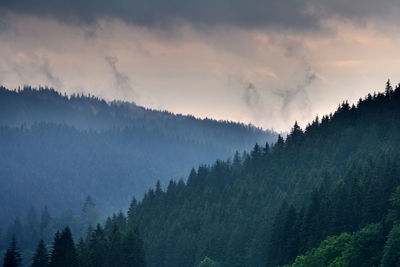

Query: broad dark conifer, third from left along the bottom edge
<box><xmin>50</xmin><ymin>227</ymin><xmax>78</xmax><ymax>267</ymax></box>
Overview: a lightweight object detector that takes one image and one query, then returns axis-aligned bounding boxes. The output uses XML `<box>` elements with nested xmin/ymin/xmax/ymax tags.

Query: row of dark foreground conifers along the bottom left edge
<box><xmin>3</xmin><ymin>214</ymin><xmax>146</xmax><ymax>267</ymax></box>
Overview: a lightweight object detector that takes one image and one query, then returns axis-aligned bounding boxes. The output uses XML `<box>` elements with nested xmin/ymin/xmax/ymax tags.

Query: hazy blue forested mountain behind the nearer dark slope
<box><xmin>0</xmin><ymin>86</ymin><xmax>277</xmax><ymax>225</ymax></box>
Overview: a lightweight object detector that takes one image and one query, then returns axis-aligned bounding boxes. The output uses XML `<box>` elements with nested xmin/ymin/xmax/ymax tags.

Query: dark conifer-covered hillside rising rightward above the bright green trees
<box><xmin>125</xmin><ymin>83</ymin><xmax>400</xmax><ymax>266</ymax></box>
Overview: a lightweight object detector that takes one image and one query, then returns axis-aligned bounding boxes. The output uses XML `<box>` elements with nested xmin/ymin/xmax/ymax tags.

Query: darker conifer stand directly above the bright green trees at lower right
<box><xmin>268</xmin><ymin>154</ymin><xmax>400</xmax><ymax>266</ymax></box>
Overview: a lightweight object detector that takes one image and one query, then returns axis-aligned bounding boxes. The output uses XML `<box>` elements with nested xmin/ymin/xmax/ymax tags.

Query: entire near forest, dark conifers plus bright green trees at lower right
<box><xmin>2</xmin><ymin>81</ymin><xmax>400</xmax><ymax>267</ymax></box>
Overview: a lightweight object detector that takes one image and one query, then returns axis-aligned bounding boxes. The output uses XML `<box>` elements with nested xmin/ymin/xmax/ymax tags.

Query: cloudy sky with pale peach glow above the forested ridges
<box><xmin>0</xmin><ymin>0</ymin><xmax>400</xmax><ymax>131</ymax></box>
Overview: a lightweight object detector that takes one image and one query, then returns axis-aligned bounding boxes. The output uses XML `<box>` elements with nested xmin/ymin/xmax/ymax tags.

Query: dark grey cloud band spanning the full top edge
<box><xmin>0</xmin><ymin>0</ymin><xmax>400</xmax><ymax>30</ymax></box>
